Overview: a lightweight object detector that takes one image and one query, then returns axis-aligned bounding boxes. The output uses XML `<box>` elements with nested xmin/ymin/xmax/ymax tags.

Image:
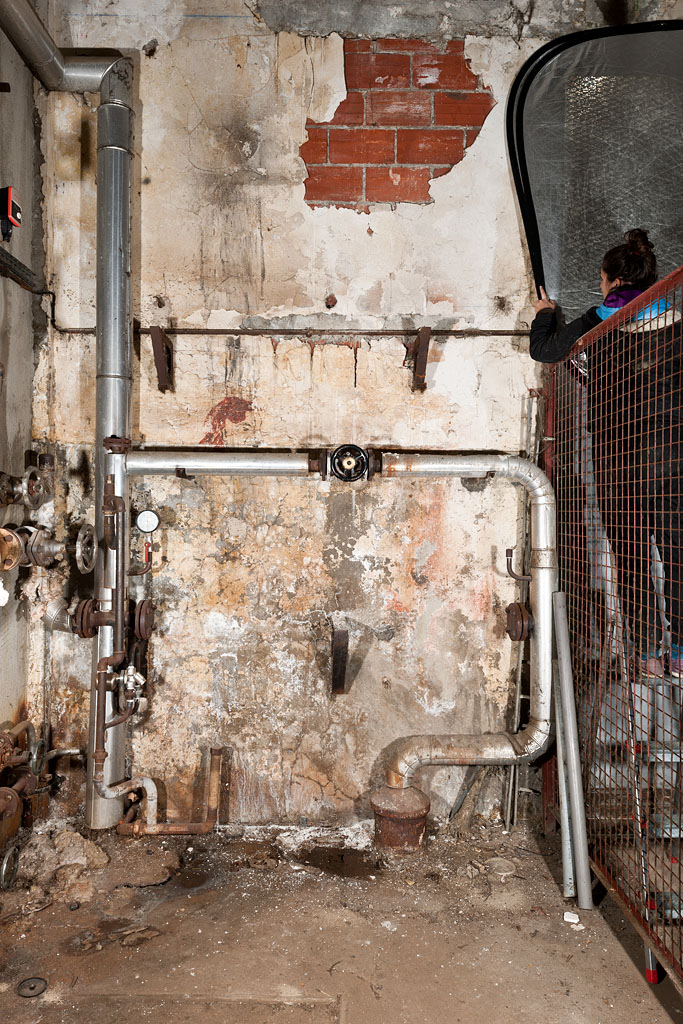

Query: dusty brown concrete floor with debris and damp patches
<box><xmin>0</xmin><ymin>825</ymin><xmax>683</xmax><ymax>1024</ymax></box>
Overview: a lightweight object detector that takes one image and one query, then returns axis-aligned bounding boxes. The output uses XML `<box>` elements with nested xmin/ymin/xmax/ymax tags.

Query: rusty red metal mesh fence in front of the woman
<box><xmin>546</xmin><ymin>267</ymin><xmax>683</xmax><ymax>978</ymax></box>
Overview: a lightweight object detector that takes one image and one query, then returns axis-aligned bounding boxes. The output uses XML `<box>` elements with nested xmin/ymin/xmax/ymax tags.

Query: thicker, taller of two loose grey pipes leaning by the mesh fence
<box><xmin>553</xmin><ymin>591</ymin><xmax>593</xmax><ymax>910</ymax></box>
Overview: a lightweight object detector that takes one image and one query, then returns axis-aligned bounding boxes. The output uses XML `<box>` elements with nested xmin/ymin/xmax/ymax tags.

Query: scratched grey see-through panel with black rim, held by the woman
<box><xmin>508</xmin><ymin>22</ymin><xmax>683</xmax><ymax>322</ymax></box>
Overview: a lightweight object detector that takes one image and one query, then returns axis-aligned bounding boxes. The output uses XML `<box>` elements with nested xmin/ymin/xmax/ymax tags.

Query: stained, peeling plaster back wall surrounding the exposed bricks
<box><xmin>28</xmin><ymin>0</ymin><xmax>679</xmax><ymax>821</ymax></box>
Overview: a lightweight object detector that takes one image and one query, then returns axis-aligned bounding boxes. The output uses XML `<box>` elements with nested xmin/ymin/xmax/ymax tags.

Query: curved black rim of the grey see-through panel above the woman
<box><xmin>505</xmin><ymin>18</ymin><xmax>683</xmax><ymax>294</ymax></box>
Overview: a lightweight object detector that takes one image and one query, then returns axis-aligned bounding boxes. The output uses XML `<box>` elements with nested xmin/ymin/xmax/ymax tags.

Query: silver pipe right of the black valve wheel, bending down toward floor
<box><xmin>382</xmin><ymin>453</ymin><xmax>557</xmax><ymax>788</ymax></box>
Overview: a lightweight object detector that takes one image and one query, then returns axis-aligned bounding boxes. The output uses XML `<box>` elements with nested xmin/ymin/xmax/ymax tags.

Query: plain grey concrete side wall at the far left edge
<box><xmin>0</xmin><ymin>34</ymin><xmax>42</xmax><ymax>722</ymax></box>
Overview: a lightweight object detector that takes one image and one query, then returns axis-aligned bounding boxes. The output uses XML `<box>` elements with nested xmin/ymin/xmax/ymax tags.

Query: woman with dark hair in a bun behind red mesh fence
<box><xmin>529</xmin><ymin>228</ymin><xmax>683</xmax><ymax>676</ymax></box>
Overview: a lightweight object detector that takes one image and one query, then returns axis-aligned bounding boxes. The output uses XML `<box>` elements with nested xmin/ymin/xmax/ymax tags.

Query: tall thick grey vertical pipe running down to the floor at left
<box><xmin>86</xmin><ymin>60</ymin><xmax>133</xmax><ymax>828</ymax></box>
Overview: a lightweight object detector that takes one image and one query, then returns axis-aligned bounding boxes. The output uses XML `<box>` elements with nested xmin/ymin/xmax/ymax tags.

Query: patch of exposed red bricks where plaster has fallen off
<box><xmin>301</xmin><ymin>39</ymin><xmax>495</xmax><ymax>212</ymax></box>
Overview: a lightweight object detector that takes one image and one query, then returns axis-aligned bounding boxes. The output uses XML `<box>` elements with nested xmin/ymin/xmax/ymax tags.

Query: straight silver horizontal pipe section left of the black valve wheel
<box><xmin>126</xmin><ymin>449</ymin><xmax>309</xmax><ymax>476</ymax></box>
